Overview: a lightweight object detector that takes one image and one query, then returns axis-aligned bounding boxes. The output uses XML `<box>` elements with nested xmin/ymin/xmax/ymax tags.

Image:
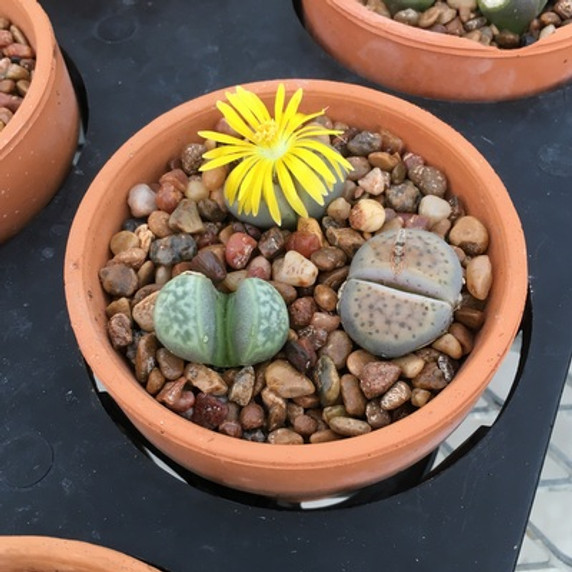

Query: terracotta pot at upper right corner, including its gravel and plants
<box><xmin>302</xmin><ymin>0</ymin><xmax>572</xmax><ymax>101</ymax></box>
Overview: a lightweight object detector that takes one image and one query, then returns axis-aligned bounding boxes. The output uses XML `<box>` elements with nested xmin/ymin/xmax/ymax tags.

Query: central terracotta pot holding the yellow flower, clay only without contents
<box><xmin>65</xmin><ymin>80</ymin><xmax>527</xmax><ymax>499</ymax></box>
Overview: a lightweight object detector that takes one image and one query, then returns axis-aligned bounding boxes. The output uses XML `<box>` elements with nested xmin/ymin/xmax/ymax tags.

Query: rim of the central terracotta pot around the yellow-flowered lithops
<box><xmin>65</xmin><ymin>79</ymin><xmax>528</xmax><ymax>472</ymax></box>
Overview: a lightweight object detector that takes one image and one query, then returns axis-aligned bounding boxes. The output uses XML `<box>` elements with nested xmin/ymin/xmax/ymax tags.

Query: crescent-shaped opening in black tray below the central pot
<box><xmin>86</xmin><ymin>292</ymin><xmax>532</xmax><ymax>510</ymax></box>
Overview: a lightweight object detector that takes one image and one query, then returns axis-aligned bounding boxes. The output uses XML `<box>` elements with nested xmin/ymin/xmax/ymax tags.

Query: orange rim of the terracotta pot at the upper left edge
<box><xmin>0</xmin><ymin>0</ymin><xmax>57</xmax><ymax>155</ymax></box>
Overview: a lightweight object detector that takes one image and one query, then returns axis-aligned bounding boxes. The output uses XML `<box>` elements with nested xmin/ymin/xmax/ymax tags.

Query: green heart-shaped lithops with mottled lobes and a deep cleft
<box><xmin>154</xmin><ymin>272</ymin><xmax>289</xmax><ymax>367</ymax></box>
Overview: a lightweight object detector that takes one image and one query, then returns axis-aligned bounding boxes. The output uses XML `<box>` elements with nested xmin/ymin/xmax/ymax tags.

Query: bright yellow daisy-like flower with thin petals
<box><xmin>199</xmin><ymin>84</ymin><xmax>352</xmax><ymax>225</ymax></box>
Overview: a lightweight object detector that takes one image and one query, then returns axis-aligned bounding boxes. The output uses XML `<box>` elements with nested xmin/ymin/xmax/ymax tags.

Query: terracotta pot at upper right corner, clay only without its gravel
<box><xmin>302</xmin><ymin>0</ymin><xmax>572</xmax><ymax>101</ymax></box>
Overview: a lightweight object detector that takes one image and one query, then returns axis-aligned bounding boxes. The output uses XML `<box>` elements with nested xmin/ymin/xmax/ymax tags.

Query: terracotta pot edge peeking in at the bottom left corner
<box><xmin>0</xmin><ymin>536</ymin><xmax>158</xmax><ymax>572</ymax></box>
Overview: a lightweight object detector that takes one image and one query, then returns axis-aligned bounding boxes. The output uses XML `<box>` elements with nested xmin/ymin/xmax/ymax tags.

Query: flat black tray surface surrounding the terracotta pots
<box><xmin>0</xmin><ymin>0</ymin><xmax>572</xmax><ymax>572</ymax></box>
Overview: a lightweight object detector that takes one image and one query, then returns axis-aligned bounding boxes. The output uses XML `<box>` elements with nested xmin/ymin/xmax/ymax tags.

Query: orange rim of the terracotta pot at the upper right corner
<box><xmin>323</xmin><ymin>0</ymin><xmax>572</xmax><ymax>60</ymax></box>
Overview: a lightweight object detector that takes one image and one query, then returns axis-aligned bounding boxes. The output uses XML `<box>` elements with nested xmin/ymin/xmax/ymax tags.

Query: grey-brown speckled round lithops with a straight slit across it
<box><xmin>338</xmin><ymin>229</ymin><xmax>463</xmax><ymax>358</ymax></box>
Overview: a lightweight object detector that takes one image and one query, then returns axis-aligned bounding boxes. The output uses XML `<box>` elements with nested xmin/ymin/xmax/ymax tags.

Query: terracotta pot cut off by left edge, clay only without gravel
<box><xmin>0</xmin><ymin>0</ymin><xmax>79</xmax><ymax>242</ymax></box>
